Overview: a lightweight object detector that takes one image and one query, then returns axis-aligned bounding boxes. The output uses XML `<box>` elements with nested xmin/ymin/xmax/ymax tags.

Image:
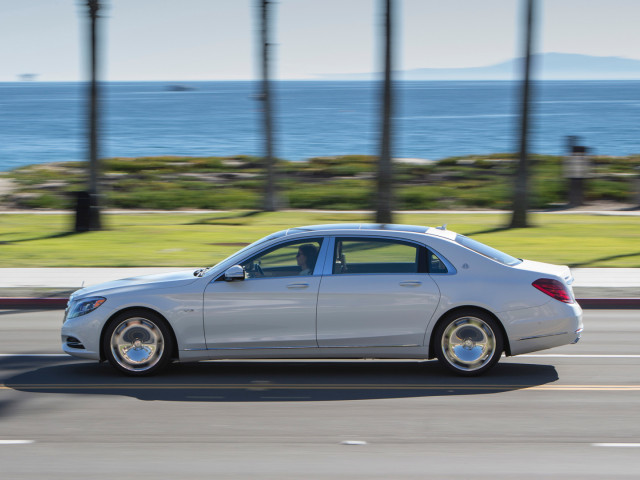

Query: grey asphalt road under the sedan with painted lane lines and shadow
<box><xmin>0</xmin><ymin>310</ymin><xmax>640</xmax><ymax>480</ymax></box>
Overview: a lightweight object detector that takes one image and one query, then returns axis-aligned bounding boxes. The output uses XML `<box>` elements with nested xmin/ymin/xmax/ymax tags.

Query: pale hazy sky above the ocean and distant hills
<box><xmin>0</xmin><ymin>0</ymin><xmax>640</xmax><ymax>81</ymax></box>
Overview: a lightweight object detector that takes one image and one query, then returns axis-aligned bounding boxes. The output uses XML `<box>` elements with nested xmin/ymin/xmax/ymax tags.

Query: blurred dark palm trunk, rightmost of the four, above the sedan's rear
<box><xmin>509</xmin><ymin>0</ymin><xmax>533</xmax><ymax>228</ymax></box>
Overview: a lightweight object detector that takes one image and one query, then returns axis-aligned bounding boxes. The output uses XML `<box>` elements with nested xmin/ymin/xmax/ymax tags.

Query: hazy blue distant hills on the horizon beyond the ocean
<box><xmin>321</xmin><ymin>53</ymin><xmax>640</xmax><ymax>80</ymax></box>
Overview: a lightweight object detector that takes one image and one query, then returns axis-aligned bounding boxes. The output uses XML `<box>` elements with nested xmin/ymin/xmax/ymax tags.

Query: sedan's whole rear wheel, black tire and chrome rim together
<box><xmin>433</xmin><ymin>309</ymin><xmax>504</xmax><ymax>377</ymax></box>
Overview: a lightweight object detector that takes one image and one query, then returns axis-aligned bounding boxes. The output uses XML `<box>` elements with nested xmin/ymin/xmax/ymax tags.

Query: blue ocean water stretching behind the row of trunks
<box><xmin>0</xmin><ymin>81</ymin><xmax>640</xmax><ymax>170</ymax></box>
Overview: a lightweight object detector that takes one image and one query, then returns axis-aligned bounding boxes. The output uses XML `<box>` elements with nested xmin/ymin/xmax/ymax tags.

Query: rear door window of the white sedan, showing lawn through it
<box><xmin>333</xmin><ymin>238</ymin><xmax>427</xmax><ymax>274</ymax></box>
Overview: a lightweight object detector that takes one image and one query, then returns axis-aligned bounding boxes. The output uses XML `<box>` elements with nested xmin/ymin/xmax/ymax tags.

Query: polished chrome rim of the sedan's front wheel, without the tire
<box><xmin>110</xmin><ymin>317</ymin><xmax>165</xmax><ymax>372</ymax></box>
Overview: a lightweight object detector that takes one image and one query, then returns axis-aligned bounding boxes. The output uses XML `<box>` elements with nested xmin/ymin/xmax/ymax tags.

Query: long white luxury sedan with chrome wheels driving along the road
<box><xmin>62</xmin><ymin>224</ymin><xmax>582</xmax><ymax>375</ymax></box>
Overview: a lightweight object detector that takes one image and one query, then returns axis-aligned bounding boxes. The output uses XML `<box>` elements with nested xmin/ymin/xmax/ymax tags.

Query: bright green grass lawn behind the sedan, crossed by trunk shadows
<box><xmin>0</xmin><ymin>211</ymin><xmax>640</xmax><ymax>267</ymax></box>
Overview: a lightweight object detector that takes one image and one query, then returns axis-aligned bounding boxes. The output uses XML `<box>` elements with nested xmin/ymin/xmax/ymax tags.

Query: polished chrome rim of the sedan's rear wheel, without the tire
<box><xmin>441</xmin><ymin>316</ymin><xmax>497</xmax><ymax>372</ymax></box>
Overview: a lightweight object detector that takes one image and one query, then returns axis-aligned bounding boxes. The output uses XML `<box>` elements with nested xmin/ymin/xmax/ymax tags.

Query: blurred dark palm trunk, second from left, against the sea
<box><xmin>258</xmin><ymin>0</ymin><xmax>278</xmax><ymax>212</ymax></box>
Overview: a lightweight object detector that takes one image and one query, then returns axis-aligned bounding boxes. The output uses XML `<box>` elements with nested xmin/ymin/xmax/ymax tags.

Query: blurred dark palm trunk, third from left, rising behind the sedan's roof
<box><xmin>376</xmin><ymin>0</ymin><xmax>393</xmax><ymax>223</ymax></box>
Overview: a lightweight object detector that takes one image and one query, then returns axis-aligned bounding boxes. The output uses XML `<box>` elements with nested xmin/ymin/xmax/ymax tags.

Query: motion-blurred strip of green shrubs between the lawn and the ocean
<box><xmin>3</xmin><ymin>153</ymin><xmax>640</xmax><ymax>210</ymax></box>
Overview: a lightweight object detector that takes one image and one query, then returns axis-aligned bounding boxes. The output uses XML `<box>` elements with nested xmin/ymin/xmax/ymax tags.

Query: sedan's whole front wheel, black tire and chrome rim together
<box><xmin>102</xmin><ymin>309</ymin><xmax>174</xmax><ymax>377</ymax></box>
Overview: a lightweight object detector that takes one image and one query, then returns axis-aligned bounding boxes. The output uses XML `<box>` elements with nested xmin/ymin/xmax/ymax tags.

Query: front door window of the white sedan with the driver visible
<box><xmin>241</xmin><ymin>238</ymin><xmax>322</xmax><ymax>278</ymax></box>
